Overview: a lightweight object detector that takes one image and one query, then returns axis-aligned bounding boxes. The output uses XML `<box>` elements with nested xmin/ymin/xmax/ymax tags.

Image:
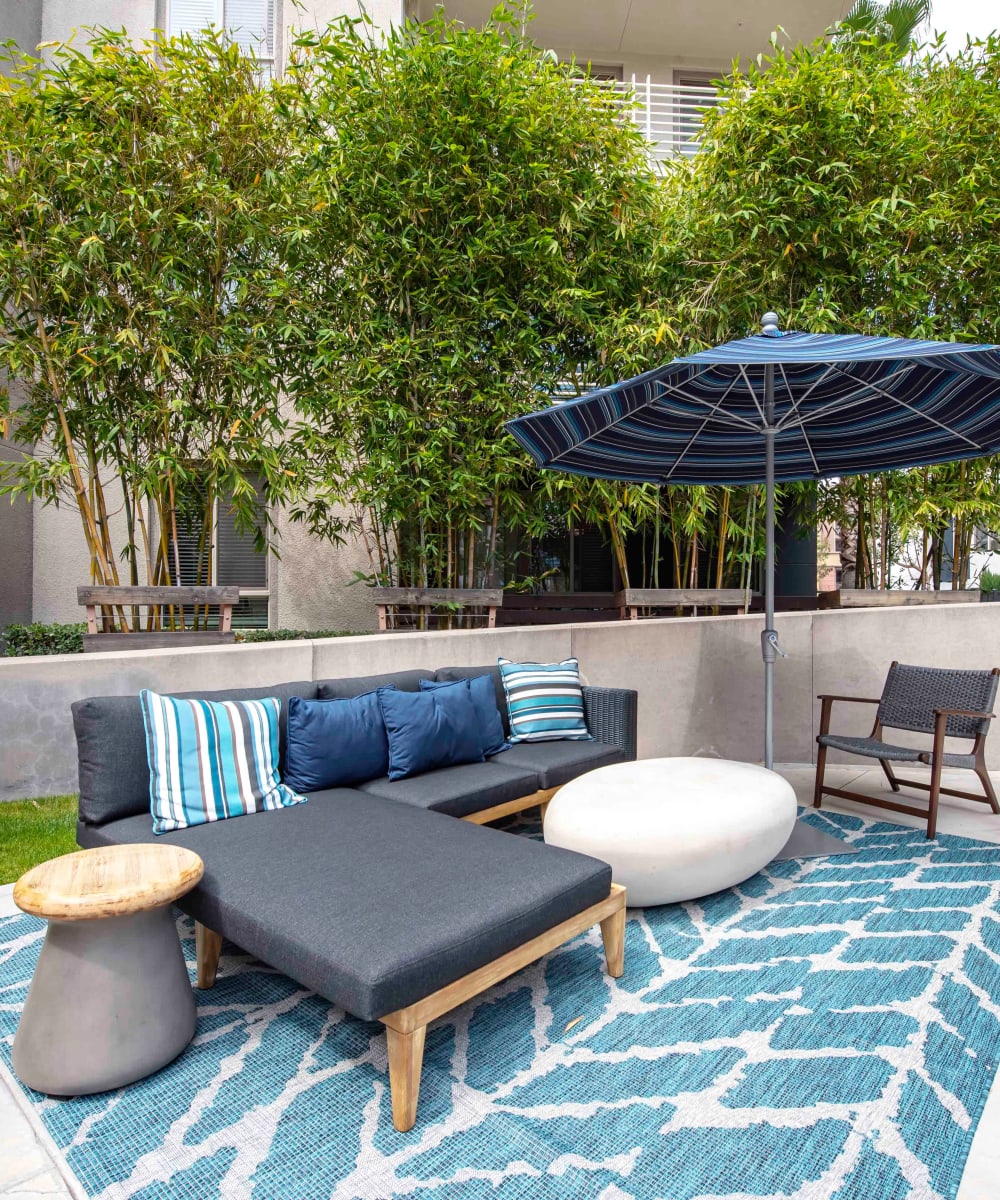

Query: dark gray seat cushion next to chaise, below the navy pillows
<box><xmin>358</xmin><ymin>754</ymin><xmax>540</xmax><ymax>817</ymax></box>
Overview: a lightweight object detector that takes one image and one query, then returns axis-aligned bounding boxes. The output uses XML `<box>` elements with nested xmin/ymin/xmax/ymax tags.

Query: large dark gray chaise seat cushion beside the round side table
<box><xmin>80</xmin><ymin>788</ymin><xmax>611</xmax><ymax>1020</ymax></box>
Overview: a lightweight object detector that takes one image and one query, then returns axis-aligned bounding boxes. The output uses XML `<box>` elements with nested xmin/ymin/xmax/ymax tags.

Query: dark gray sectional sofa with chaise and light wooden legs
<box><xmin>73</xmin><ymin>666</ymin><xmax>636</xmax><ymax>1132</ymax></box>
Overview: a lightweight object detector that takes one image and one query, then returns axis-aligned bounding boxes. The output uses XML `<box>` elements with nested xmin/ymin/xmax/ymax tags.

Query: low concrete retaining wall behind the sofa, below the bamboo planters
<box><xmin>0</xmin><ymin>604</ymin><xmax>1000</xmax><ymax>799</ymax></box>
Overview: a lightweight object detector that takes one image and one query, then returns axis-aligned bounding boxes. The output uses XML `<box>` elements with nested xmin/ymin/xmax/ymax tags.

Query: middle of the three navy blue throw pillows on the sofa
<box><xmin>378</xmin><ymin>679</ymin><xmax>483</xmax><ymax>779</ymax></box>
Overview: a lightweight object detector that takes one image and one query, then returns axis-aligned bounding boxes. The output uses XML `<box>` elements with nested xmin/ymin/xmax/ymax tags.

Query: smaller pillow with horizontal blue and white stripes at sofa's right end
<box><xmin>497</xmin><ymin>659</ymin><xmax>593</xmax><ymax>742</ymax></box>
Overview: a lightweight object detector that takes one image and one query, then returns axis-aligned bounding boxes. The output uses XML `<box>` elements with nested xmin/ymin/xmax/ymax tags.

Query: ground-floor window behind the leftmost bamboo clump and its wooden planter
<box><xmin>178</xmin><ymin>475</ymin><xmax>270</xmax><ymax>629</ymax></box>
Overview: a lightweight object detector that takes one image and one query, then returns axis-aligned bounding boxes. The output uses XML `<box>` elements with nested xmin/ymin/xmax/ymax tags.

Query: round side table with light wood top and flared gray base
<box><xmin>12</xmin><ymin>844</ymin><xmax>204</xmax><ymax>1096</ymax></box>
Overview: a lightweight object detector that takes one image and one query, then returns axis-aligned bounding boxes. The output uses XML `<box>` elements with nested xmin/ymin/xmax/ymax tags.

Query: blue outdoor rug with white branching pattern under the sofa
<box><xmin>0</xmin><ymin>814</ymin><xmax>1000</xmax><ymax>1200</ymax></box>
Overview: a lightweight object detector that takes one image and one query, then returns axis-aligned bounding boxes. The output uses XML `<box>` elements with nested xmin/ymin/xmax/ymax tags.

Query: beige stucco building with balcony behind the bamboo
<box><xmin>0</xmin><ymin>0</ymin><xmax>850</xmax><ymax>630</ymax></box>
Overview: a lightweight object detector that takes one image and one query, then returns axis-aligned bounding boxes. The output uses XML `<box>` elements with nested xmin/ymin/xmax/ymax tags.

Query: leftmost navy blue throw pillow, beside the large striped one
<box><xmin>283</xmin><ymin>689</ymin><xmax>390</xmax><ymax>792</ymax></box>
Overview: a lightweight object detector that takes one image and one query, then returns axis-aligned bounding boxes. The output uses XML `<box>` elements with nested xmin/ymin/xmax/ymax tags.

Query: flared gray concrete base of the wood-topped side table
<box><xmin>12</xmin><ymin>905</ymin><xmax>194</xmax><ymax>1096</ymax></box>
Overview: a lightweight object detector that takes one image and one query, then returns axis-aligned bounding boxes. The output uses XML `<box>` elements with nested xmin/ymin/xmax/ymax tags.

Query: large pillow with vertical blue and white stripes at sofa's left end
<box><xmin>139</xmin><ymin>690</ymin><xmax>305</xmax><ymax>833</ymax></box>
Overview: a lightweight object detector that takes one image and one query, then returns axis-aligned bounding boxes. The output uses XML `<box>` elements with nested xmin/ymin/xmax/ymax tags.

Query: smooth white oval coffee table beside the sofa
<box><xmin>545</xmin><ymin>758</ymin><xmax>797</xmax><ymax>907</ymax></box>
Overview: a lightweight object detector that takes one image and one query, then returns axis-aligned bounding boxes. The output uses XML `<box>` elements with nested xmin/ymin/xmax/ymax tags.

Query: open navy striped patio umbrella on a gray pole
<box><xmin>507</xmin><ymin>312</ymin><xmax>1000</xmax><ymax>768</ymax></box>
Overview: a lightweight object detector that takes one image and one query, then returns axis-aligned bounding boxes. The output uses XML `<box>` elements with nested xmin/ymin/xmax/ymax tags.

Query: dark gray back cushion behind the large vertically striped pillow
<box><xmin>72</xmin><ymin>680</ymin><xmax>316</xmax><ymax>834</ymax></box>
